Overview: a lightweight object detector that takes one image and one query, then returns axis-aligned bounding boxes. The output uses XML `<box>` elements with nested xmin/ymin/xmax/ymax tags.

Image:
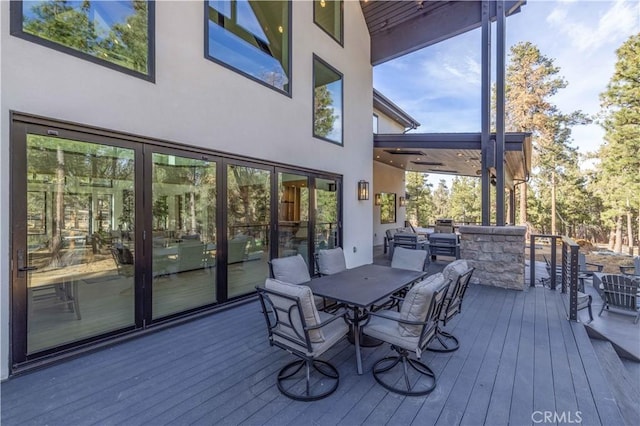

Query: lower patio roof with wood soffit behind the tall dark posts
<box><xmin>373</xmin><ymin>133</ymin><xmax>531</xmax><ymax>187</ymax></box>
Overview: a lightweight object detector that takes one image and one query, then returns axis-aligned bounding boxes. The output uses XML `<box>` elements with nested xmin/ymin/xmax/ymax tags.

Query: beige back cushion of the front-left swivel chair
<box><xmin>264</xmin><ymin>278</ymin><xmax>324</xmax><ymax>343</ymax></box>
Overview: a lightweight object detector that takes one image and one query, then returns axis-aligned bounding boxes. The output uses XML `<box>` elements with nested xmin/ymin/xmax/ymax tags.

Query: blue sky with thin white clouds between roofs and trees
<box><xmin>373</xmin><ymin>0</ymin><xmax>640</xmax><ymax>160</ymax></box>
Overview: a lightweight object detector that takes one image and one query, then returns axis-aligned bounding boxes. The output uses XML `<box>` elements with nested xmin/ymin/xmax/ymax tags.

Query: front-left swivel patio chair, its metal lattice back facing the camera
<box><xmin>256</xmin><ymin>279</ymin><xmax>349</xmax><ymax>401</ymax></box>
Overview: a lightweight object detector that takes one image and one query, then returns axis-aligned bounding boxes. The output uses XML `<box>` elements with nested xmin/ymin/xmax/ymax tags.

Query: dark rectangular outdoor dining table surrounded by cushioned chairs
<box><xmin>307</xmin><ymin>264</ymin><xmax>427</xmax><ymax>374</ymax></box>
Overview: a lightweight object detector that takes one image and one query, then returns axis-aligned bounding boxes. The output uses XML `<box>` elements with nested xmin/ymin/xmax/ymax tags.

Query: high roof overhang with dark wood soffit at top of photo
<box><xmin>360</xmin><ymin>0</ymin><xmax>526</xmax><ymax>65</ymax></box>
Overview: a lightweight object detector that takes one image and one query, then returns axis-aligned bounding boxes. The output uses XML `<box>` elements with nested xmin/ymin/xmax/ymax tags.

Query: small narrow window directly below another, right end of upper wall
<box><xmin>313</xmin><ymin>56</ymin><xmax>342</xmax><ymax>145</ymax></box>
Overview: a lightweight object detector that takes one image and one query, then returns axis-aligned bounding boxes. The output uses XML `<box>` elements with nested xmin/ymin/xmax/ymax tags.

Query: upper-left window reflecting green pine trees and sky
<box><xmin>11</xmin><ymin>0</ymin><xmax>154</xmax><ymax>80</ymax></box>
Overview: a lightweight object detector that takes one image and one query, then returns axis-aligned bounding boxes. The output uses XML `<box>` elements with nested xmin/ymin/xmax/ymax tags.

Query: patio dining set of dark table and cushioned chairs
<box><xmin>257</xmin><ymin>247</ymin><xmax>473</xmax><ymax>401</ymax></box>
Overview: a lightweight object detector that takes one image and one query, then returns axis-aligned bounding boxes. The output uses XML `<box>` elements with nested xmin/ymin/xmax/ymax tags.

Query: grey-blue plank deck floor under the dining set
<box><xmin>1</xmin><ymin>278</ymin><xmax>624</xmax><ymax>426</ymax></box>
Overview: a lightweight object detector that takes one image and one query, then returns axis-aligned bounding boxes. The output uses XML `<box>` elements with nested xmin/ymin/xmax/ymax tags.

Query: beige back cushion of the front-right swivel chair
<box><xmin>398</xmin><ymin>273</ymin><xmax>447</xmax><ymax>337</ymax></box>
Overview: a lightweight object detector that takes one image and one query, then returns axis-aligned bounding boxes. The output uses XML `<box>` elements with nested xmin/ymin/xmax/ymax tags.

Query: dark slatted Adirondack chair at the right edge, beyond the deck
<box><xmin>598</xmin><ymin>275</ymin><xmax>640</xmax><ymax>324</ymax></box>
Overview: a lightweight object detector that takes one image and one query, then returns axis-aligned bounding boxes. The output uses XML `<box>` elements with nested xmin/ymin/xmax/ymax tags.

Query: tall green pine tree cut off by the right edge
<box><xmin>599</xmin><ymin>33</ymin><xmax>640</xmax><ymax>252</ymax></box>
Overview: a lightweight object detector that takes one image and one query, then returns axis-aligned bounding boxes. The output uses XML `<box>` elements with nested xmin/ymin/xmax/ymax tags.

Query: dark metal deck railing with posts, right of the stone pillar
<box><xmin>529</xmin><ymin>234</ymin><xmax>580</xmax><ymax>321</ymax></box>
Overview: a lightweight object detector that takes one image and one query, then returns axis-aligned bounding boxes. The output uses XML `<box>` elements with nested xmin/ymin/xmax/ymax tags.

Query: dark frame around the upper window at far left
<box><xmin>9</xmin><ymin>0</ymin><xmax>156</xmax><ymax>83</ymax></box>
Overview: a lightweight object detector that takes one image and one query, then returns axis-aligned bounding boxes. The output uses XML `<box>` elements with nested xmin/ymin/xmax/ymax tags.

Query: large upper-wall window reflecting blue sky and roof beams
<box><xmin>205</xmin><ymin>0</ymin><xmax>291</xmax><ymax>93</ymax></box>
